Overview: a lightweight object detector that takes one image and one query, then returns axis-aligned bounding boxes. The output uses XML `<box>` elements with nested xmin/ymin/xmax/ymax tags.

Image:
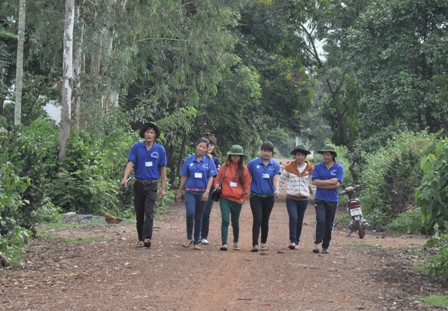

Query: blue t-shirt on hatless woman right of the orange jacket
<box><xmin>247</xmin><ymin>157</ymin><xmax>280</xmax><ymax>195</ymax></box>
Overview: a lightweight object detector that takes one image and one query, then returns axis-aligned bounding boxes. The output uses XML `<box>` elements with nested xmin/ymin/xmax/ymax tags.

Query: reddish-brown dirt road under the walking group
<box><xmin>0</xmin><ymin>197</ymin><xmax>447</xmax><ymax>311</ymax></box>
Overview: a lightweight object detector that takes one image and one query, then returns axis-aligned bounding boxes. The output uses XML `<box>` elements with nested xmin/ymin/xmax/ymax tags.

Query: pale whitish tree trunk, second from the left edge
<box><xmin>58</xmin><ymin>0</ymin><xmax>75</xmax><ymax>165</ymax></box>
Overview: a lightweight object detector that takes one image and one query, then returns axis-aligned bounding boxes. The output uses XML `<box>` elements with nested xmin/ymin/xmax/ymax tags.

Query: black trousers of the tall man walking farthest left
<box><xmin>134</xmin><ymin>182</ymin><xmax>157</xmax><ymax>241</ymax></box>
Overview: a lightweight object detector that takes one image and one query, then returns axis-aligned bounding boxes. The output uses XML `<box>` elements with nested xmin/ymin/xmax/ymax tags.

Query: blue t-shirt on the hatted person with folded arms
<box><xmin>311</xmin><ymin>162</ymin><xmax>344</xmax><ymax>202</ymax></box>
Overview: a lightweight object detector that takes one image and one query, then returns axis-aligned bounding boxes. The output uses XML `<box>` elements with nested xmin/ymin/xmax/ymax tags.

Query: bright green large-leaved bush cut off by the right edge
<box><xmin>415</xmin><ymin>138</ymin><xmax>448</xmax><ymax>231</ymax></box>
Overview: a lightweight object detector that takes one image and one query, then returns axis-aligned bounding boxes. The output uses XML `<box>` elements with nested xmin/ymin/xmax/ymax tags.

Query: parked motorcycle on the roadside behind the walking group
<box><xmin>339</xmin><ymin>185</ymin><xmax>369</xmax><ymax>239</ymax></box>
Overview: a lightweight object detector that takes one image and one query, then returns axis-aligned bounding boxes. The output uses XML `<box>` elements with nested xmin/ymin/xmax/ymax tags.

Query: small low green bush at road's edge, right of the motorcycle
<box><xmin>386</xmin><ymin>206</ymin><xmax>425</xmax><ymax>234</ymax></box>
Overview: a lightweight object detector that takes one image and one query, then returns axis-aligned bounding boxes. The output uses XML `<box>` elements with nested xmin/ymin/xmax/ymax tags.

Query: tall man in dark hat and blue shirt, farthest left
<box><xmin>121</xmin><ymin>122</ymin><xmax>167</xmax><ymax>247</ymax></box>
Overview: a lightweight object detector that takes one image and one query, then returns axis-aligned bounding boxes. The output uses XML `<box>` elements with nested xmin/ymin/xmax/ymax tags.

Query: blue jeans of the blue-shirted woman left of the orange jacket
<box><xmin>184</xmin><ymin>191</ymin><xmax>206</xmax><ymax>245</ymax></box>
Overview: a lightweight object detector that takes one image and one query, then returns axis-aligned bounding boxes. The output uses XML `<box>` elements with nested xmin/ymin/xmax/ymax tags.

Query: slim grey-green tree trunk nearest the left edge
<box><xmin>14</xmin><ymin>0</ymin><xmax>26</xmax><ymax>125</ymax></box>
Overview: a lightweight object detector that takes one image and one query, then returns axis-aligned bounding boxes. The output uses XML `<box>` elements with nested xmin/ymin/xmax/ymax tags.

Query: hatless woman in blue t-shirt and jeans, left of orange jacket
<box><xmin>176</xmin><ymin>137</ymin><xmax>217</xmax><ymax>250</ymax></box>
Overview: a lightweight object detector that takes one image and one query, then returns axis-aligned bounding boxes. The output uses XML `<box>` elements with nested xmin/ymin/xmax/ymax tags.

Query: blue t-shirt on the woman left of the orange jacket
<box><xmin>180</xmin><ymin>154</ymin><xmax>217</xmax><ymax>190</ymax></box>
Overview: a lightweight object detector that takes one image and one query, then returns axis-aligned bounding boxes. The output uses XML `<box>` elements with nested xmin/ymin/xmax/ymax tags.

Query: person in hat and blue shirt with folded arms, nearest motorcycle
<box><xmin>311</xmin><ymin>145</ymin><xmax>344</xmax><ymax>254</ymax></box>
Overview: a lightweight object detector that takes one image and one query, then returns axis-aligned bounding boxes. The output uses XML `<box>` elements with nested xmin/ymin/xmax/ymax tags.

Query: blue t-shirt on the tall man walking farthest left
<box><xmin>128</xmin><ymin>141</ymin><xmax>166</xmax><ymax>180</ymax></box>
